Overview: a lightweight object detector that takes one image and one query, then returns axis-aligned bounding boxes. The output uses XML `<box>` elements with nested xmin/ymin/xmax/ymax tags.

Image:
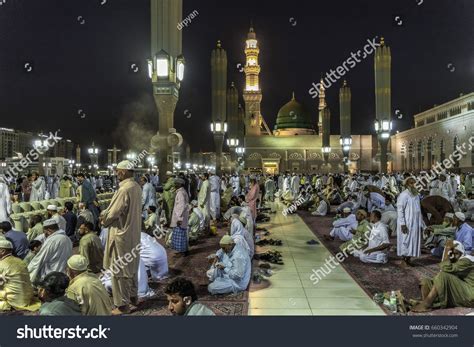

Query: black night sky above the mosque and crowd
<box><xmin>0</xmin><ymin>0</ymin><xmax>474</xmax><ymax>162</ymax></box>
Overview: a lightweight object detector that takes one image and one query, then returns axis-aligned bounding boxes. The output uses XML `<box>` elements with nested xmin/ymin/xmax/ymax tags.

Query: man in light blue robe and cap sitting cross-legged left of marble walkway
<box><xmin>207</xmin><ymin>235</ymin><xmax>251</xmax><ymax>294</ymax></box>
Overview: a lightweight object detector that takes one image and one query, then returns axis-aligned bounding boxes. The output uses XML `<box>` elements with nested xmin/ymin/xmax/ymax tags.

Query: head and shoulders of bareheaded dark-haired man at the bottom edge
<box><xmin>165</xmin><ymin>277</ymin><xmax>215</xmax><ymax>316</ymax></box>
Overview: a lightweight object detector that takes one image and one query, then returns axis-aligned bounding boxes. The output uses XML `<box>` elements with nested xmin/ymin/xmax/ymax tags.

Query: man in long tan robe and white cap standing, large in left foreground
<box><xmin>101</xmin><ymin>160</ymin><xmax>142</xmax><ymax>315</ymax></box>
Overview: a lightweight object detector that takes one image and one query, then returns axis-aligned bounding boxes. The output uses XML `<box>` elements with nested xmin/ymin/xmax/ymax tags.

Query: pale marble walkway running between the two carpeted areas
<box><xmin>249</xmin><ymin>207</ymin><xmax>385</xmax><ymax>316</ymax></box>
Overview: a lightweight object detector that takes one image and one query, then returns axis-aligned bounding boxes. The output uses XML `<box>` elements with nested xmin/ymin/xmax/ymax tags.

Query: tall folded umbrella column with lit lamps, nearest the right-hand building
<box><xmin>374</xmin><ymin>37</ymin><xmax>392</xmax><ymax>173</ymax></box>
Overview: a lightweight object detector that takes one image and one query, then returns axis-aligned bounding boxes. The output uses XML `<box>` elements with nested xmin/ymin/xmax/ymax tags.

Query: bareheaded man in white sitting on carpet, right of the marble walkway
<box><xmin>353</xmin><ymin>210</ymin><xmax>390</xmax><ymax>264</ymax></box>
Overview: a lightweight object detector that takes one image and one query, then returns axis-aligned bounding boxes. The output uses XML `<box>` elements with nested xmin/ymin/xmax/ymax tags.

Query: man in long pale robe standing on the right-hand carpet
<box><xmin>397</xmin><ymin>177</ymin><xmax>425</xmax><ymax>266</ymax></box>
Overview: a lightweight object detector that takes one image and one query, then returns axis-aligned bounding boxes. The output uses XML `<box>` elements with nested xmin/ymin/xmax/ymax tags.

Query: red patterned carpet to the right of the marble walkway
<box><xmin>298</xmin><ymin>211</ymin><xmax>474</xmax><ymax>315</ymax></box>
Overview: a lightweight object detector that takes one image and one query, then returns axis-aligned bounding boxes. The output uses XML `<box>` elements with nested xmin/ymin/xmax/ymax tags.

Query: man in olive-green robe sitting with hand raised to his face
<box><xmin>412</xmin><ymin>241</ymin><xmax>474</xmax><ymax>312</ymax></box>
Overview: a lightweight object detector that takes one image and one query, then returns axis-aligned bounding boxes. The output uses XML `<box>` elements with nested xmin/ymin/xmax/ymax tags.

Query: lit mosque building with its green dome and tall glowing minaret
<box><xmin>243</xmin><ymin>28</ymin><xmax>379</xmax><ymax>174</ymax></box>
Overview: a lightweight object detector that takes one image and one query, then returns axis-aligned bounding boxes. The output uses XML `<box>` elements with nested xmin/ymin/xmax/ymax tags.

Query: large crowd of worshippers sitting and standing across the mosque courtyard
<box><xmin>0</xmin><ymin>161</ymin><xmax>474</xmax><ymax>315</ymax></box>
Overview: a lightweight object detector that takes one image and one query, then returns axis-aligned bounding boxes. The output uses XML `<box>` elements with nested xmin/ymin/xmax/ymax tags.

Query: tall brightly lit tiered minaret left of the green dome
<box><xmin>244</xmin><ymin>26</ymin><xmax>262</xmax><ymax>136</ymax></box>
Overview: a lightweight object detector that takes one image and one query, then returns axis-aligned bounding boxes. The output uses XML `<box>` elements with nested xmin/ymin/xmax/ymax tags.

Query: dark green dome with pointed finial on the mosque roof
<box><xmin>275</xmin><ymin>94</ymin><xmax>314</xmax><ymax>130</ymax></box>
